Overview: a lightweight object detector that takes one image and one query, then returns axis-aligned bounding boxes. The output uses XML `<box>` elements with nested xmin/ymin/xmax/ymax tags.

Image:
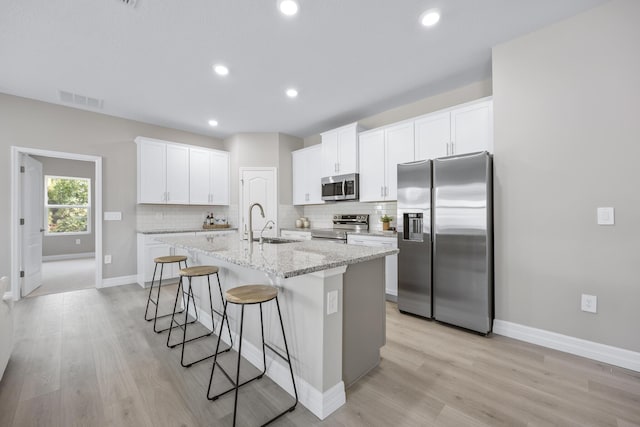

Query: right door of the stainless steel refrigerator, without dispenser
<box><xmin>433</xmin><ymin>152</ymin><xmax>493</xmax><ymax>334</ymax></box>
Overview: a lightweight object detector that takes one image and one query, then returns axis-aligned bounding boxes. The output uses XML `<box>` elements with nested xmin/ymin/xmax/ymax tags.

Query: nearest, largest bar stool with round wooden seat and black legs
<box><xmin>207</xmin><ymin>285</ymin><xmax>298</xmax><ymax>426</ymax></box>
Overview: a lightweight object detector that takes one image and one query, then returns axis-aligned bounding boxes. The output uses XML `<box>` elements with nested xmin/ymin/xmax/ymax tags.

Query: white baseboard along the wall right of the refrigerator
<box><xmin>493</xmin><ymin>319</ymin><xmax>640</xmax><ymax>372</ymax></box>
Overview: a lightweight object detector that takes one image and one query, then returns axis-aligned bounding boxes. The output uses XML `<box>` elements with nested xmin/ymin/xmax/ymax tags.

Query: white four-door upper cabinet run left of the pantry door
<box><xmin>135</xmin><ymin>137</ymin><xmax>229</xmax><ymax>205</ymax></box>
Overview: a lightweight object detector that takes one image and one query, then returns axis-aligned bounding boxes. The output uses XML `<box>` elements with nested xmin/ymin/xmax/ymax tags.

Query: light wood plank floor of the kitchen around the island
<box><xmin>0</xmin><ymin>285</ymin><xmax>640</xmax><ymax>427</ymax></box>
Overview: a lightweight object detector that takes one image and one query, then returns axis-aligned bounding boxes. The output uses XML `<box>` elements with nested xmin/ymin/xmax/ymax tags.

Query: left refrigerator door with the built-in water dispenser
<box><xmin>397</xmin><ymin>160</ymin><xmax>432</xmax><ymax>317</ymax></box>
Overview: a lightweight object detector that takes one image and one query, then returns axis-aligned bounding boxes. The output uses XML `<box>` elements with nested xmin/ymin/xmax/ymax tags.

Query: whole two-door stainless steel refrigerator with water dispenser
<box><xmin>398</xmin><ymin>152</ymin><xmax>493</xmax><ymax>334</ymax></box>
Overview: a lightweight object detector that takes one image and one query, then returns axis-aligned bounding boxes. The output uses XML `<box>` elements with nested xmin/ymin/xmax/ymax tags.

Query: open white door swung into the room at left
<box><xmin>22</xmin><ymin>155</ymin><xmax>44</xmax><ymax>295</ymax></box>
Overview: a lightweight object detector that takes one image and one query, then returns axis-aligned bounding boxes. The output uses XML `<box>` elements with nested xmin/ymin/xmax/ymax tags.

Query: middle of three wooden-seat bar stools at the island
<box><xmin>167</xmin><ymin>265</ymin><xmax>233</xmax><ymax>368</ymax></box>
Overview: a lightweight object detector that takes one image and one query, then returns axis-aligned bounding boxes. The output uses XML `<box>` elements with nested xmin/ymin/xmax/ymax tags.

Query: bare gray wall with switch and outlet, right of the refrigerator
<box><xmin>493</xmin><ymin>0</ymin><xmax>640</xmax><ymax>351</ymax></box>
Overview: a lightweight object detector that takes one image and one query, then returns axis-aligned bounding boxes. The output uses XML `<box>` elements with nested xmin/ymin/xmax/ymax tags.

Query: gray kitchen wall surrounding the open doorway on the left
<box><xmin>0</xmin><ymin>94</ymin><xmax>224</xmax><ymax>278</ymax></box>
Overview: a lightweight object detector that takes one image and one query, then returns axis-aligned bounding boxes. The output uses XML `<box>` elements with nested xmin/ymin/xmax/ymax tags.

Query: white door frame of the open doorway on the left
<box><xmin>11</xmin><ymin>146</ymin><xmax>102</xmax><ymax>301</ymax></box>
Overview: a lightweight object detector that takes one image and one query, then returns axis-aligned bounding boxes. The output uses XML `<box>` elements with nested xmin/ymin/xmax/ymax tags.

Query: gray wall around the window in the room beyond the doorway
<box><xmin>32</xmin><ymin>156</ymin><xmax>96</xmax><ymax>256</ymax></box>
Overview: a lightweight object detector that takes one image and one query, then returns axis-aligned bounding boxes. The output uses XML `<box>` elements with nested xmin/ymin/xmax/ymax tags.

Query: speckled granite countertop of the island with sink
<box><xmin>159</xmin><ymin>233</ymin><xmax>399</xmax><ymax>279</ymax></box>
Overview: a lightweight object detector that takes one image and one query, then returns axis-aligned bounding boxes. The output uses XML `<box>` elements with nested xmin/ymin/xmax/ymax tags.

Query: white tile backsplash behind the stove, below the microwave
<box><xmin>304</xmin><ymin>202</ymin><xmax>397</xmax><ymax>230</ymax></box>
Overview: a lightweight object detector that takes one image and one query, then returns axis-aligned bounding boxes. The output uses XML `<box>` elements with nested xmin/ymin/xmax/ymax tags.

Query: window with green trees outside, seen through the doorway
<box><xmin>44</xmin><ymin>175</ymin><xmax>91</xmax><ymax>236</ymax></box>
